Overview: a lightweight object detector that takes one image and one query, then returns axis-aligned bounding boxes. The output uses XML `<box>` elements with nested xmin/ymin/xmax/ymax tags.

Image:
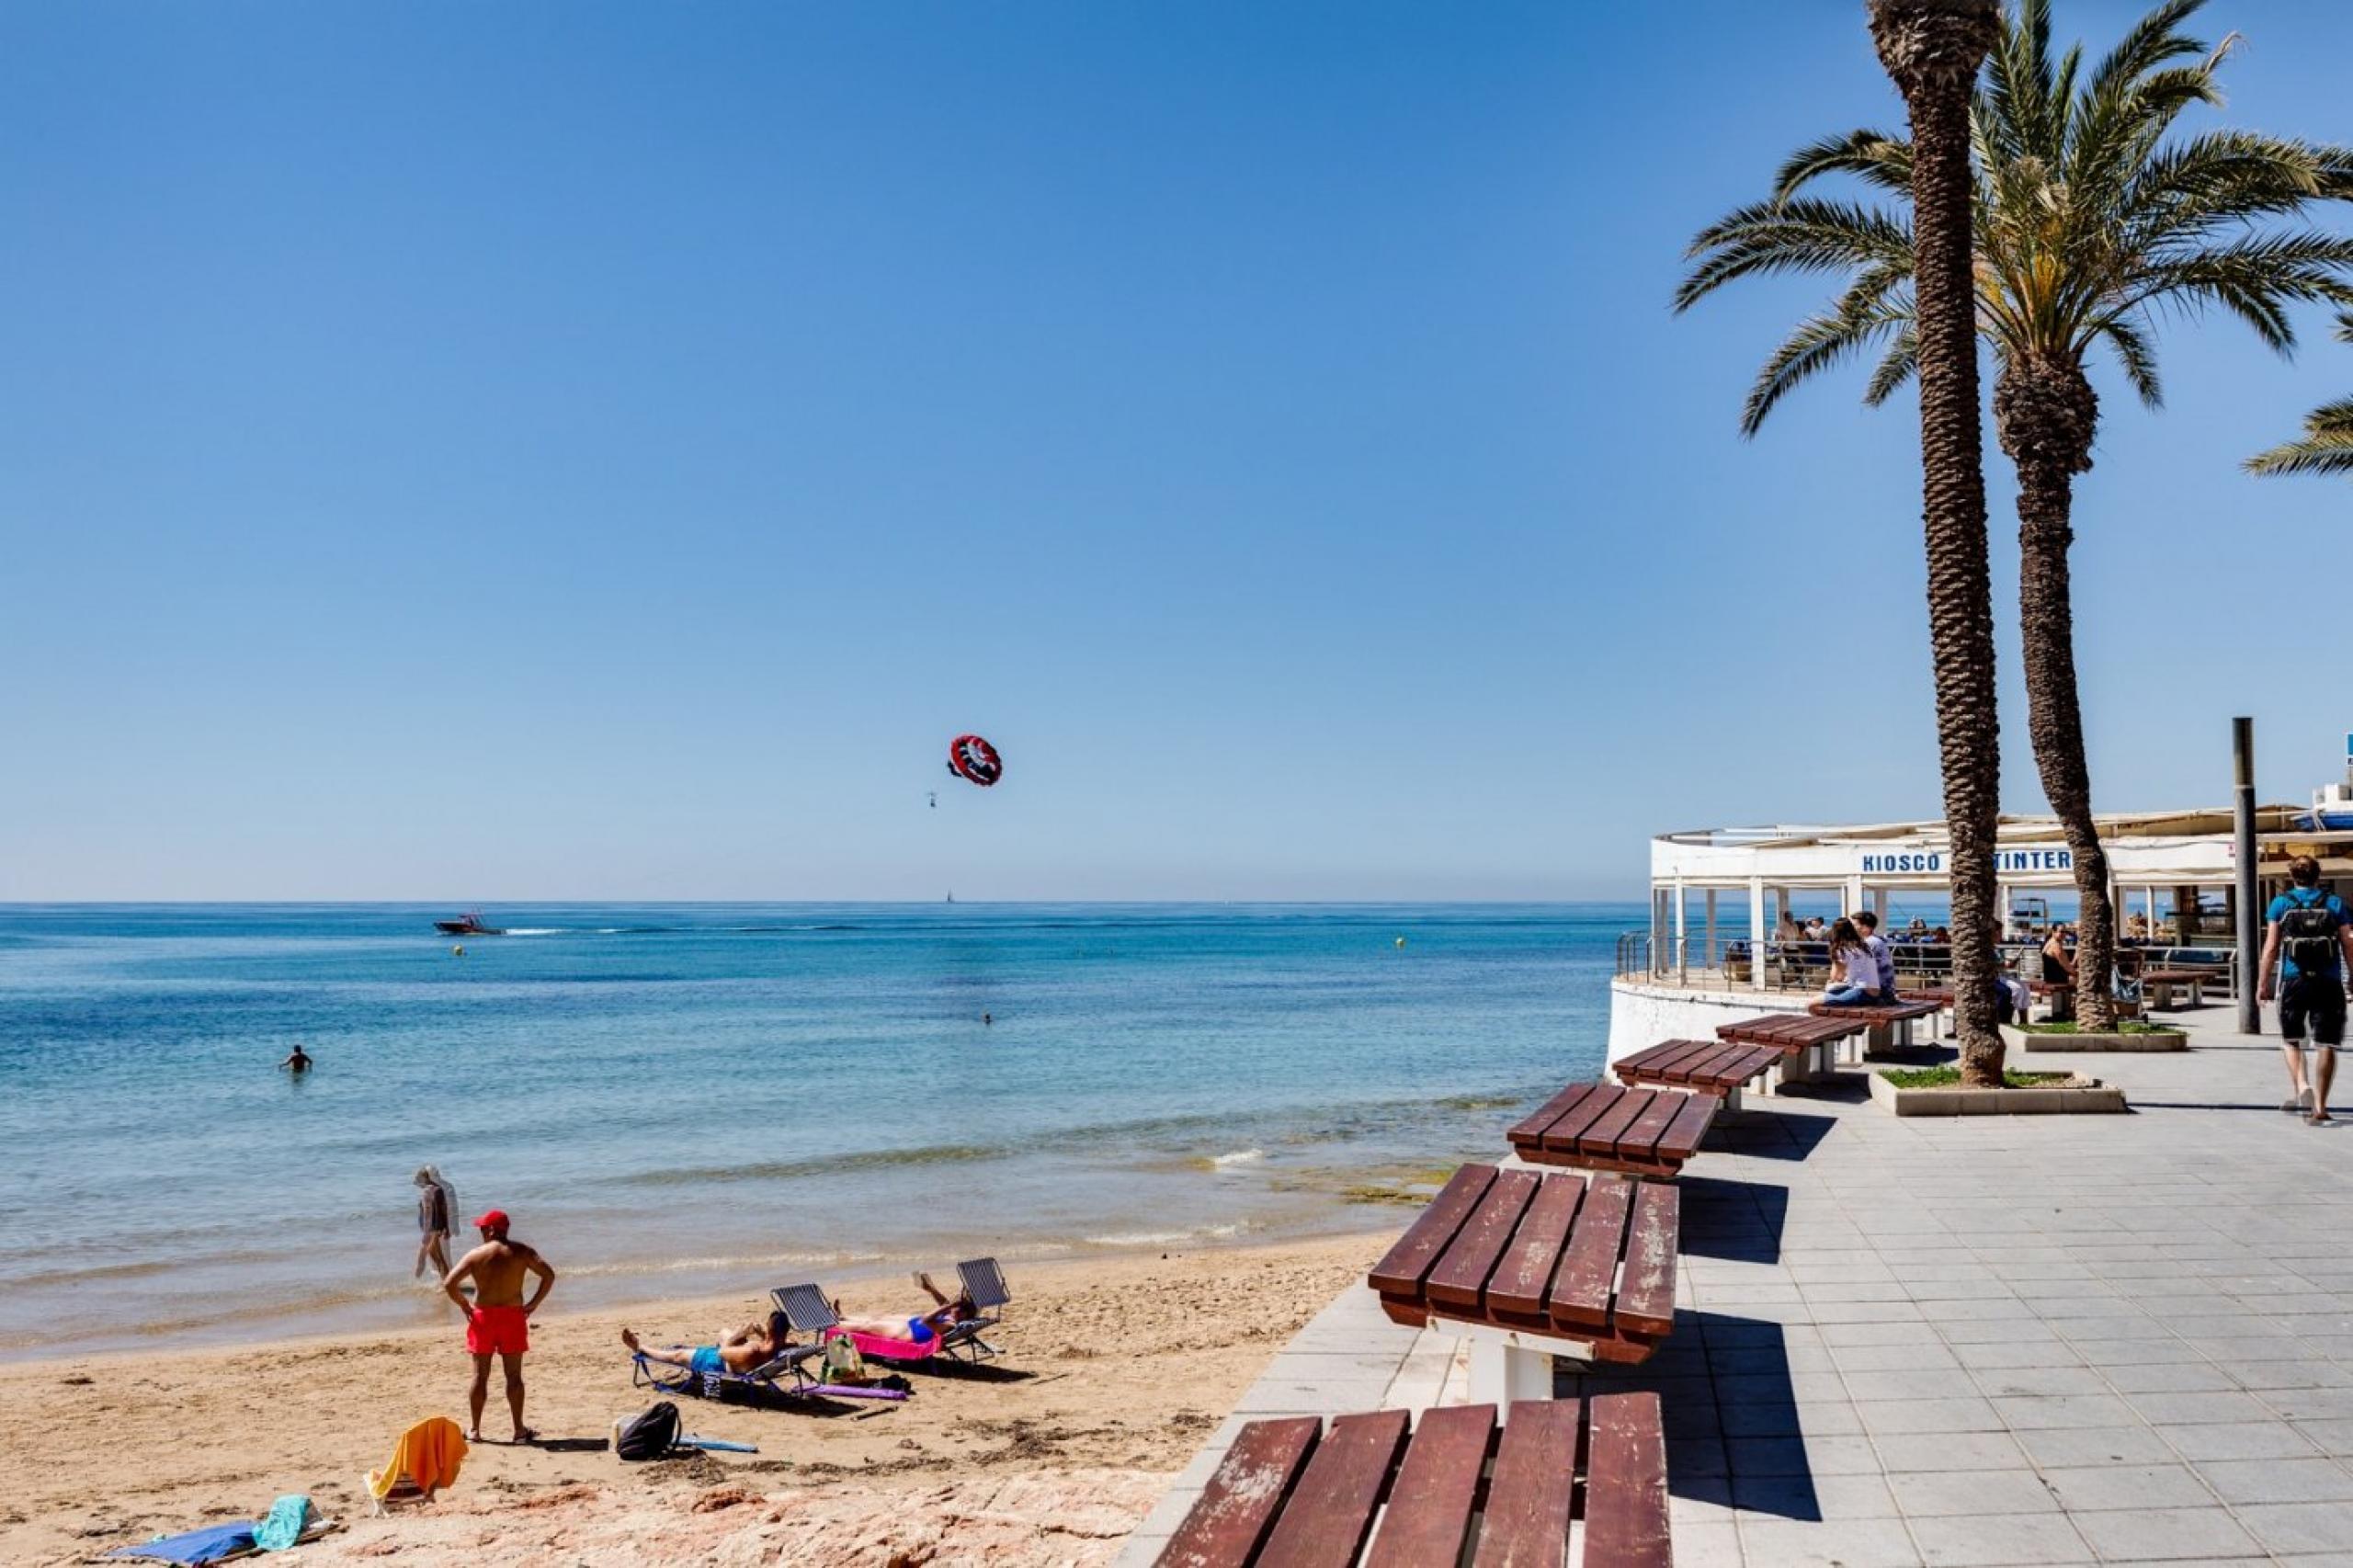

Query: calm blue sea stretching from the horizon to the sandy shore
<box><xmin>0</xmin><ymin>904</ymin><xmax>1647</xmax><ymax>1356</ymax></box>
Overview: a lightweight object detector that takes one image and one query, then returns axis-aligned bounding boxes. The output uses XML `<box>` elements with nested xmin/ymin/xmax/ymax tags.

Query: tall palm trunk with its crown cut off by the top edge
<box><xmin>1869</xmin><ymin>0</ymin><xmax>2003</xmax><ymax>1087</ymax></box>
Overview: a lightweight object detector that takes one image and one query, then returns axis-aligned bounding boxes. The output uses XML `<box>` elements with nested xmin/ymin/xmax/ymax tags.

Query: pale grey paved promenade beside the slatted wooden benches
<box><xmin>1122</xmin><ymin>1006</ymin><xmax>2353</xmax><ymax>1568</ymax></box>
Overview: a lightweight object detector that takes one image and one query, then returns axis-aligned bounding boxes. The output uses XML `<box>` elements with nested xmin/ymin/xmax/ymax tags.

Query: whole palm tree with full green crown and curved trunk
<box><xmin>1677</xmin><ymin>0</ymin><xmax>2353</xmax><ymax>1028</ymax></box>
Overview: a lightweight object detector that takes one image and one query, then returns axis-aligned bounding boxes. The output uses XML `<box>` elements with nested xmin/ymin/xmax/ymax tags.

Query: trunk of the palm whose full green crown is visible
<box><xmin>1993</xmin><ymin>360</ymin><xmax>2115</xmax><ymax>1031</ymax></box>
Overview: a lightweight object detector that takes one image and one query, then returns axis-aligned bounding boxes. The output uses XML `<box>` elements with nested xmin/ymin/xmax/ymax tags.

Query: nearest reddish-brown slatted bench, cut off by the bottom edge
<box><xmin>1160</xmin><ymin>1392</ymin><xmax>1676</xmax><ymax>1568</ymax></box>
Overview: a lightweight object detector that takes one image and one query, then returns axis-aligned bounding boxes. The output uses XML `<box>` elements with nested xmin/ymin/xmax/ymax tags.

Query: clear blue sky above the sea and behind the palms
<box><xmin>0</xmin><ymin>0</ymin><xmax>2353</xmax><ymax>902</ymax></box>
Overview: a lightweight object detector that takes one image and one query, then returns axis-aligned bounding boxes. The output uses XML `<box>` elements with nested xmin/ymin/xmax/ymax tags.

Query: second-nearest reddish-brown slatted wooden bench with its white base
<box><xmin>1365</xmin><ymin>1165</ymin><xmax>1682</xmax><ymax>1403</ymax></box>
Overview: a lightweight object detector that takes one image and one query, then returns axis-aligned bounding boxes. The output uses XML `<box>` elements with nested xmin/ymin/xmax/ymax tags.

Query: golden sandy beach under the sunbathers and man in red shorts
<box><xmin>0</xmin><ymin>1236</ymin><xmax>1386</xmax><ymax>1568</ymax></box>
